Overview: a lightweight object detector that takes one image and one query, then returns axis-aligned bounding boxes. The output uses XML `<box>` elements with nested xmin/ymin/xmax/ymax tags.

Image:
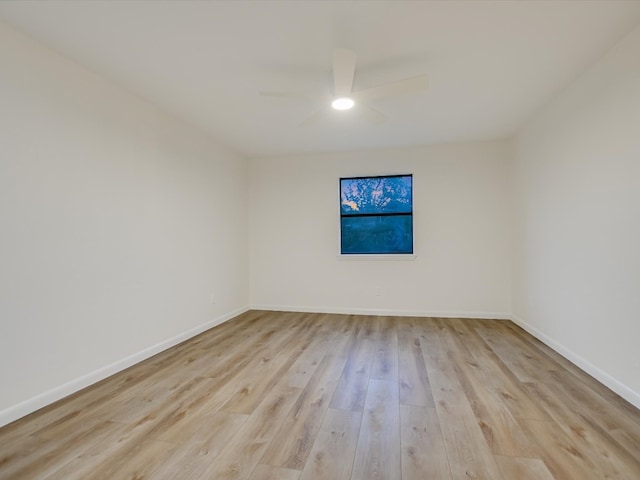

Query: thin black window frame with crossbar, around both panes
<box><xmin>338</xmin><ymin>173</ymin><xmax>416</xmax><ymax>255</ymax></box>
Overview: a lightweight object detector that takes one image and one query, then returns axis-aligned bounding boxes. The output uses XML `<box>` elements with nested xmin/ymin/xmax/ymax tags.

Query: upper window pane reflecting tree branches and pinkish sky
<box><xmin>340</xmin><ymin>175</ymin><xmax>412</xmax><ymax>215</ymax></box>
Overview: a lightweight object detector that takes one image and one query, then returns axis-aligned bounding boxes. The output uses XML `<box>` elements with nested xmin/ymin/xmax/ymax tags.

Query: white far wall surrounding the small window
<box><xmin>249</xmin><ymin>141</ymin><xmax>511</xmax><ymax>317</ymax></box>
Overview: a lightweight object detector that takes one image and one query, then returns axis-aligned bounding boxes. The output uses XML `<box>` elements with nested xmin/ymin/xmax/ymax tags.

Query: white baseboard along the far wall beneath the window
<box><xmin>251</xmin><ymin>304</ymin><xmax>511</xmax><ymax>320</ymax></box>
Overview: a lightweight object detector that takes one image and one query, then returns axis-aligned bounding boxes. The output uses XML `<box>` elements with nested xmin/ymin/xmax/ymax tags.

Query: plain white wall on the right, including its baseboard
<box><xmin>514</xmin><ymin>22</ymin><xmax>640</xmax><ymax>407</ymax></box>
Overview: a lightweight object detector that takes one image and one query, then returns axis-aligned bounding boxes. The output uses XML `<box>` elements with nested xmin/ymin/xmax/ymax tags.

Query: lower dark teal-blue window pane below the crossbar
<box><xmin>340</xmin><ymin>215</ymin><xmax>413</xmax><ymax>254</ymax></box>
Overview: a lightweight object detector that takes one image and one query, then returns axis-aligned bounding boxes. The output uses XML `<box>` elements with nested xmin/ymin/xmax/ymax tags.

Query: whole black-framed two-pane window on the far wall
<box><xmin>340</xmin><ymin>175</ymin><xmax>413</xmax><ymax>255</ymax></box>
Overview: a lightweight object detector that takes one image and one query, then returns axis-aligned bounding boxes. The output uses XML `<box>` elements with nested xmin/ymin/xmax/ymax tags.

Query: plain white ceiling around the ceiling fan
<box><xmin>0</xmin><ymin>0</ymin><xmax>640</xmax><ymax>157</ymax></box>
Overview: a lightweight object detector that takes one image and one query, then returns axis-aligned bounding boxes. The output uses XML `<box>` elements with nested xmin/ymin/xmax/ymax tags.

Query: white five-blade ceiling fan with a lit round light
<box><xmin>260</xmin><ymin>48</ymin><xmax>427</xmax><ymax>127</ymax></box>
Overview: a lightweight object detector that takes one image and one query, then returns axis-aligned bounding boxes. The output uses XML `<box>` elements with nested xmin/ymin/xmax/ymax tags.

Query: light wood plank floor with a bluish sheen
<box><xmin>0</xmin><ymin>311</ymin><xmax>640</xmax><ymax>480</ymax></box>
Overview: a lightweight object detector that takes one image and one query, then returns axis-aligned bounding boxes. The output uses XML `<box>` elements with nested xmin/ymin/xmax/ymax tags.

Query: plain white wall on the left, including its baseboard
<box><xmin>0</xmin><ymin>18</ymin><xmax>249</xmax><ymax>425</ymax></box>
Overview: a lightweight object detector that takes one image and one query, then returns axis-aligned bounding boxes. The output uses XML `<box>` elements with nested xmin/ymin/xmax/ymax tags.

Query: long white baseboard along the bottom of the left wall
<box><xmin>0</xmin><ymin>306</ymin><xmax>249</xmax><ymax>427</ymax></box>
